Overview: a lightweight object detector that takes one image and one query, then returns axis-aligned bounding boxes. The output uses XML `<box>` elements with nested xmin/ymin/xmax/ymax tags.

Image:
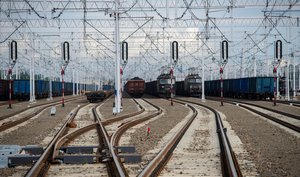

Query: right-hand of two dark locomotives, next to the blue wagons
<box><xmin>176</xmin><ymin>74</ymin><xmax>202</xmax><ymax>97</ymax></box>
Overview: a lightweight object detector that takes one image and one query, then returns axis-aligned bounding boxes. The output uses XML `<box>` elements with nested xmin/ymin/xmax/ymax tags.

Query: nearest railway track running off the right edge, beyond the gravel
<box><xmin>206</xmin><ymin>99</ymin><xmax>300</xmax><ymax>133</ymax></box>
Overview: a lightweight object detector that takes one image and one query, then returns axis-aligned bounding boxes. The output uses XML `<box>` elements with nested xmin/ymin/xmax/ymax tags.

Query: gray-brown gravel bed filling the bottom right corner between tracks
<box><xmin>189</xmin><ymin>98</ymin><xmax>300</xmax><ymax>177</ymax></box>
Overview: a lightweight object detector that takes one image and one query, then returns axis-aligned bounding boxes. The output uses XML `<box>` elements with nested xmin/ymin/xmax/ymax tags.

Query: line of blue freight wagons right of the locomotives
<box><xmin>205</xmin><ymin>77</ymin><xmax>274</xmax><ymax>99</ymax></box>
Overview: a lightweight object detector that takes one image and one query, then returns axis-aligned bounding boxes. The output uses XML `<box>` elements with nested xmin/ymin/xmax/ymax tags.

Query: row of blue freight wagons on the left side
<box><xmin>0</xmin><ymin>80</ymin><xmax>98</xmax><ymax>101</ymax></box>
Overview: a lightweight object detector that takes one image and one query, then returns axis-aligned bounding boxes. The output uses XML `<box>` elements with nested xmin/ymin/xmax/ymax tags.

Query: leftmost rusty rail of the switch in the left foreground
<box><xmin>25</xmin><ymin>104</ymin><xmax>87</xmax><ymax>177</ymax></box>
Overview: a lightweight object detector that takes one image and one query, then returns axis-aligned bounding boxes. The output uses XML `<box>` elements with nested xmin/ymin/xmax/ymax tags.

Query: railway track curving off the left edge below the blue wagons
<box><xmin>0</xmin><ymin>97</ymin><xmax>82</xmax><ymax>132</ymax></box>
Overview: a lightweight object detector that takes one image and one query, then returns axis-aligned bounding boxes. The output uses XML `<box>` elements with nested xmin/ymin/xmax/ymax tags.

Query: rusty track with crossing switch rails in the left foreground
<box><xmin>26</xmin><ymin>97</ymin><xmax>152</xmax><ymax>176</ymax></box>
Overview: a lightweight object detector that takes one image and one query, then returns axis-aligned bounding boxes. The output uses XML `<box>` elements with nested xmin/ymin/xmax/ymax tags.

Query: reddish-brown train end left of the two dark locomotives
<box><xmin>124</xmin><ymin>77</ymin><xmax>145</xmax><ymax>98</ymax></box>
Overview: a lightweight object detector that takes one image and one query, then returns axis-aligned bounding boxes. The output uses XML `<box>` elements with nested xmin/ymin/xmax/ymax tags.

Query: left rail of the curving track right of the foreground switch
<box><xmin>138</xmin><ymin>100</ymin><xmax>198</xmax><ymax>177</ymax></box>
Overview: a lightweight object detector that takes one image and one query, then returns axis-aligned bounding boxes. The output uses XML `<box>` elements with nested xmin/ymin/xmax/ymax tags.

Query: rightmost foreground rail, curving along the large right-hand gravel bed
<box><xmin>177</xmin><ymin>99</ymin><xmax>242</xmax><ymax>177</ymax></box>
